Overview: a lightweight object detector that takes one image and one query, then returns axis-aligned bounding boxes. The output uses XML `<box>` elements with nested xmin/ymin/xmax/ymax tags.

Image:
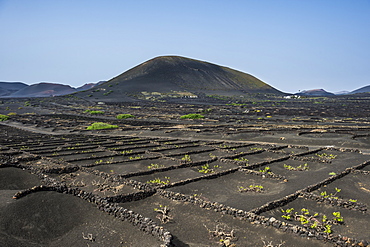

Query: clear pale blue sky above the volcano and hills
<box><xmin>0</xmin><ymin>0</ymin><xmax>370</xmax><ymax>93</ymax></box>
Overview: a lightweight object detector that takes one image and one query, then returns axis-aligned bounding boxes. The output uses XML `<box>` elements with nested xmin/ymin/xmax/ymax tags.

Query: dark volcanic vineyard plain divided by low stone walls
<box><xmin>0</xmin><ymin>97</ymin><xmax>370</xmax><ymax>246</ymax></box>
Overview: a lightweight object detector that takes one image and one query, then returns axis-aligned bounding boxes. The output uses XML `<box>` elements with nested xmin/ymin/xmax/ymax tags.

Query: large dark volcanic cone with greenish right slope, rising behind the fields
<box><xmin>76</xmin><ymin>56</ymin><xmax>283</xmax><ymax>101</ymax></box>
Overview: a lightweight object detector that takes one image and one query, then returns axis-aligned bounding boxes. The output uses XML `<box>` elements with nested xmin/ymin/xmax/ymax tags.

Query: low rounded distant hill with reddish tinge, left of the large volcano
<box><xmin>10</xmin><ymin>82</ymin><xmax>77</xmax><ymax>97</ymax></box>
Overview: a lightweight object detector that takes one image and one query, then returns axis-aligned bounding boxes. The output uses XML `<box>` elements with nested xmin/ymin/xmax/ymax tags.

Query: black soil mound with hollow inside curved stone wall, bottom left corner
<box><xmin>0</xmin><ymin>192</ymin><xmax>160</xmax><ymax>246</ymax></box>
